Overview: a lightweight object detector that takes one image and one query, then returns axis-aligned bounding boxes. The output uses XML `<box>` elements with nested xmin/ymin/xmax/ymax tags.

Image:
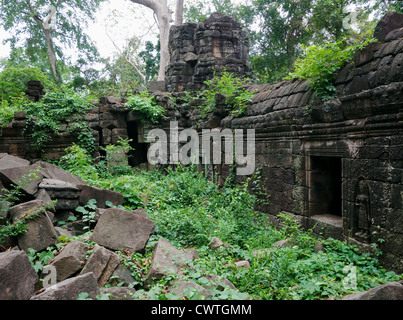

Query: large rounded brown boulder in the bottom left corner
<box><xmin>0</xmin><ymin>250</ymin><xmax>38</xmax><ymax>300</ymax></box>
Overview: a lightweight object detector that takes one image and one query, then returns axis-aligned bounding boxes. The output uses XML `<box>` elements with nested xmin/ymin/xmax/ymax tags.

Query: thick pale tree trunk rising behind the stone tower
<box><xmin>130</xmin><ymin>0</ymin><xmax>183</xmax><ymax>81</ymax></box>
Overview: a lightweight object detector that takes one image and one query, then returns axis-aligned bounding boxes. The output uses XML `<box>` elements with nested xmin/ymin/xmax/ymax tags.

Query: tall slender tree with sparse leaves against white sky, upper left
<box><xmin>0</xmin><ymin>0</ymin><xmax>103</xmax><ymax>83</ymax></box>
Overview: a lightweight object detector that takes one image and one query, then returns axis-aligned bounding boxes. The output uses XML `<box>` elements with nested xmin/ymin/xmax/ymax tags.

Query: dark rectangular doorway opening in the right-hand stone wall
<box><xmin>309</xmin><ymin>156</ymin><xmax>342</xmax><ymax>216</ymax></box>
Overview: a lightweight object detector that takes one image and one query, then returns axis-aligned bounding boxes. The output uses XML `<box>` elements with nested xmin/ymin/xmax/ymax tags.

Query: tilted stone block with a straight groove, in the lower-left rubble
<box><xmin>81</xmin><ymin>245</ymin><xmax>120</xmax><ymax>287</ymax></box>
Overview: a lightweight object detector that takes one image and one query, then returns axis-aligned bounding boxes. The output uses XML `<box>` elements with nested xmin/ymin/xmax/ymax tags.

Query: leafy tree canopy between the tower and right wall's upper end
<box><xmin>251</xmin><ymin>0</ymin><xmax>372</xmax><ymax>82</ymax></box>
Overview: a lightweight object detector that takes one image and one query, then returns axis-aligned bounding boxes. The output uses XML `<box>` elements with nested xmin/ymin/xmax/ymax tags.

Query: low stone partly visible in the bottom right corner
<box><xmin>343</xmin><ymin>282</ymin><xmax>403</xmax><ymax>300</ymax></box>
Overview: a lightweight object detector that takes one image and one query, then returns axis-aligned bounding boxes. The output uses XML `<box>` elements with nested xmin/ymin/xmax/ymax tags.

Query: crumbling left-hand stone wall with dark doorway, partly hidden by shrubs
<box><xmin>0</xmin><ymin>97</ymin><xmax>147</xmax><ymax>166</ymax></box>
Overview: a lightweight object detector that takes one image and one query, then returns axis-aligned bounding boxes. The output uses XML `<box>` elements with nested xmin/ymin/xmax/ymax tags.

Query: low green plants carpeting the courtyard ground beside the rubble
<box><xmin>54</xmin><ymin>146</ymin><xmax>401</xmax><ymax>300</ymax></box>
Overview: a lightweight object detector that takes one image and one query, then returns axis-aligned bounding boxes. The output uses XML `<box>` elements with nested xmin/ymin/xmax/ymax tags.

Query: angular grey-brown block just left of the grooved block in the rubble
<box><xmin>50</xmin><ymin>241</ymin><xmax>89</xmax><ymax>282</ymax></box>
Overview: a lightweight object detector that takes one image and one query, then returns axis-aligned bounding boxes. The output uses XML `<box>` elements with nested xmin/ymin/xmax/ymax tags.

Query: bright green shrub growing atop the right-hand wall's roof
<box><xmin>286</xmin><ymin>38</ymin><xmax>375</xmax><ymax>100</ymax></box>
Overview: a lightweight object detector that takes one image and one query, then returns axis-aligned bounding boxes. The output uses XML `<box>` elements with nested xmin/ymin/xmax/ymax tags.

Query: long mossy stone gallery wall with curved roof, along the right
<box><xmin>152</xmin><ymin>14</ymin><xmax>403</xmax><ymax>272</ymax></box>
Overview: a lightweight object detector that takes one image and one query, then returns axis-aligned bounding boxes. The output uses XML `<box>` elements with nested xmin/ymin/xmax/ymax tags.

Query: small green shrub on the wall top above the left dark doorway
<box><xmin>125</xmin><ymin>90</ymin><xmax>165</xmax><ymax>123</ymax></box>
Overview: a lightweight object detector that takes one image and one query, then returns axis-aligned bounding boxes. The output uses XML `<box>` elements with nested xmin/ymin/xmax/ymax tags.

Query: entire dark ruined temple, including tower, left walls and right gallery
<box><xmin>0</xmin><ymin>14</ymin><xmax>403</xmax><ymax>272</ymax></box>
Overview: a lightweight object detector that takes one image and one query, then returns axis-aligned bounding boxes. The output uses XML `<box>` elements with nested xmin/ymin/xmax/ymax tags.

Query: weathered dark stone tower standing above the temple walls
<box><xmin>165</xmin><ymin>13</ymin><xmax>252</xmax><ymax>92</ymax></box>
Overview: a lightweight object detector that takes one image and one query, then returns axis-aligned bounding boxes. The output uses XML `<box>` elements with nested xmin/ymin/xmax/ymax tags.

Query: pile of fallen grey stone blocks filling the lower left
<box><xmin>0</xmin><ymin>154</ymin><xmax>248</xmax><ymax>300</ymax></box>
